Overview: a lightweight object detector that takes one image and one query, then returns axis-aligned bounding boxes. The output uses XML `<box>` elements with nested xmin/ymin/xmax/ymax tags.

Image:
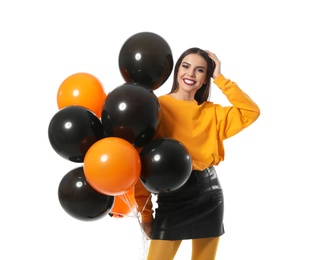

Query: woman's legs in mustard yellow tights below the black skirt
<box><xmin>147</xmin><ymin>237</ymin><xmax>219</xmax><ymax>260</ymax></box>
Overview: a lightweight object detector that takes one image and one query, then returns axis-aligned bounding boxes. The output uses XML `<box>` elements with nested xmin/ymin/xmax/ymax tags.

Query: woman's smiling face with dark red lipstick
<box><xmin>177</xmin><ymin>54</ymin><xmax>208</xmax><ymax>93</ymax></box>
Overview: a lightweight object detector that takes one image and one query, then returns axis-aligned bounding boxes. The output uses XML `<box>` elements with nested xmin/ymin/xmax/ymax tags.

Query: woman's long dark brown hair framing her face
<box><xmin>170</xmin><ymin>47</ymin><xmax>215</xmax><ymax>105</ymax></box>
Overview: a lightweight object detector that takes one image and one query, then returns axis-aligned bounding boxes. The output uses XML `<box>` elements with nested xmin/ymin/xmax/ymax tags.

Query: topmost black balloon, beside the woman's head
<box><xmin>119</xmin><ymin>32</ymin><xmax>173</xmax><ymax>90</ymax></box>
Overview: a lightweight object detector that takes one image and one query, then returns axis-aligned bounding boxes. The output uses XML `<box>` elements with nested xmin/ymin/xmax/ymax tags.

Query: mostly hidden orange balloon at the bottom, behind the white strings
<box><xmin>109</xmin><ymin>188</ymin><xmax>137</xmax><ymax>218</ymax></box>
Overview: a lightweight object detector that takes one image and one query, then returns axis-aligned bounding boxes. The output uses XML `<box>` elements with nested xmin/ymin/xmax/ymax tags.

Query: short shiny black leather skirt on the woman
<box><xmin>151</xmin><ymin>167</ymin><xmax>224</xmax><ymax>240</ymax></box>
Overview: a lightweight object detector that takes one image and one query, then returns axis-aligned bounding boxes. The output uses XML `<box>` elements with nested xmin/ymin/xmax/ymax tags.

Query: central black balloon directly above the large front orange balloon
<box><xmin>101</xmin><ymin>83</ymin><xmax>160</xmax><ymax>147</ymax></box>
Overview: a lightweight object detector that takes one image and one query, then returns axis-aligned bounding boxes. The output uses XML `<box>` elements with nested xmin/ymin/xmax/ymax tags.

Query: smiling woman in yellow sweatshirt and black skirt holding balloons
<box><xmin>135</xmin><ymin>48</ymin><xmax>260</xmax><ymax>260</ymax></box>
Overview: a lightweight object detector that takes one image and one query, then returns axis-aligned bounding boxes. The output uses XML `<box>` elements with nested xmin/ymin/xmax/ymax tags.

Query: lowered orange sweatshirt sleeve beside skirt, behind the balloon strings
<box><xmin>135</xmin><ymin>180</ymin><xmax>153</xmax><ymax>222</ymax></box>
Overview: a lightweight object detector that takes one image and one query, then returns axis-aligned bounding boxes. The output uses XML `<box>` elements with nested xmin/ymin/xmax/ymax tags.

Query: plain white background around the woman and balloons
<box><xmin>0</xmin><ymin>0</ymin><xmax>320</xmax><ymax>260</ymax></box>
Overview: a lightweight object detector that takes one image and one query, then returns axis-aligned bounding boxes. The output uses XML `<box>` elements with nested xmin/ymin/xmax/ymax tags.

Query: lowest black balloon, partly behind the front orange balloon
<box><xmin>58</xmin><ymin>167</ymin><xmax>114</xmax><ymax>221</ymax></box>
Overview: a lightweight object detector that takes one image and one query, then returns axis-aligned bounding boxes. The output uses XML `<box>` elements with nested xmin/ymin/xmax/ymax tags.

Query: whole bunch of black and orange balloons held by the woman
<box><xmin>48</xmin><ymin>32</ymin><xmax>191</xmax><ymax>221</ymax></box>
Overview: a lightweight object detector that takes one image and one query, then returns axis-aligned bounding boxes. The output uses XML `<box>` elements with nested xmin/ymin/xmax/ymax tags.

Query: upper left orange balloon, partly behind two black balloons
<box><xmin>57</xmin><ymin>72</ymin><xmax>106</xmax><ymax>117</ymax></box>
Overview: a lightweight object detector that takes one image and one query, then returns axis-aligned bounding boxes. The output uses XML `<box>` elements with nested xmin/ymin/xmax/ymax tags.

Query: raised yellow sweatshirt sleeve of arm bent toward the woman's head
<box><xmin>214</xmin><ymin>74</ymin><xmax>260</xmax><ymax>139</ymax></box>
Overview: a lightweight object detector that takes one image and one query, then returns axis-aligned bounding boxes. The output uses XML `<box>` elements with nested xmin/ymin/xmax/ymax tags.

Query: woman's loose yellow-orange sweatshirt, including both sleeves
<box><xmin>135</xmin><ymin>74</ymin><xmax>260</xmax><ymax>222</ymax></box>
